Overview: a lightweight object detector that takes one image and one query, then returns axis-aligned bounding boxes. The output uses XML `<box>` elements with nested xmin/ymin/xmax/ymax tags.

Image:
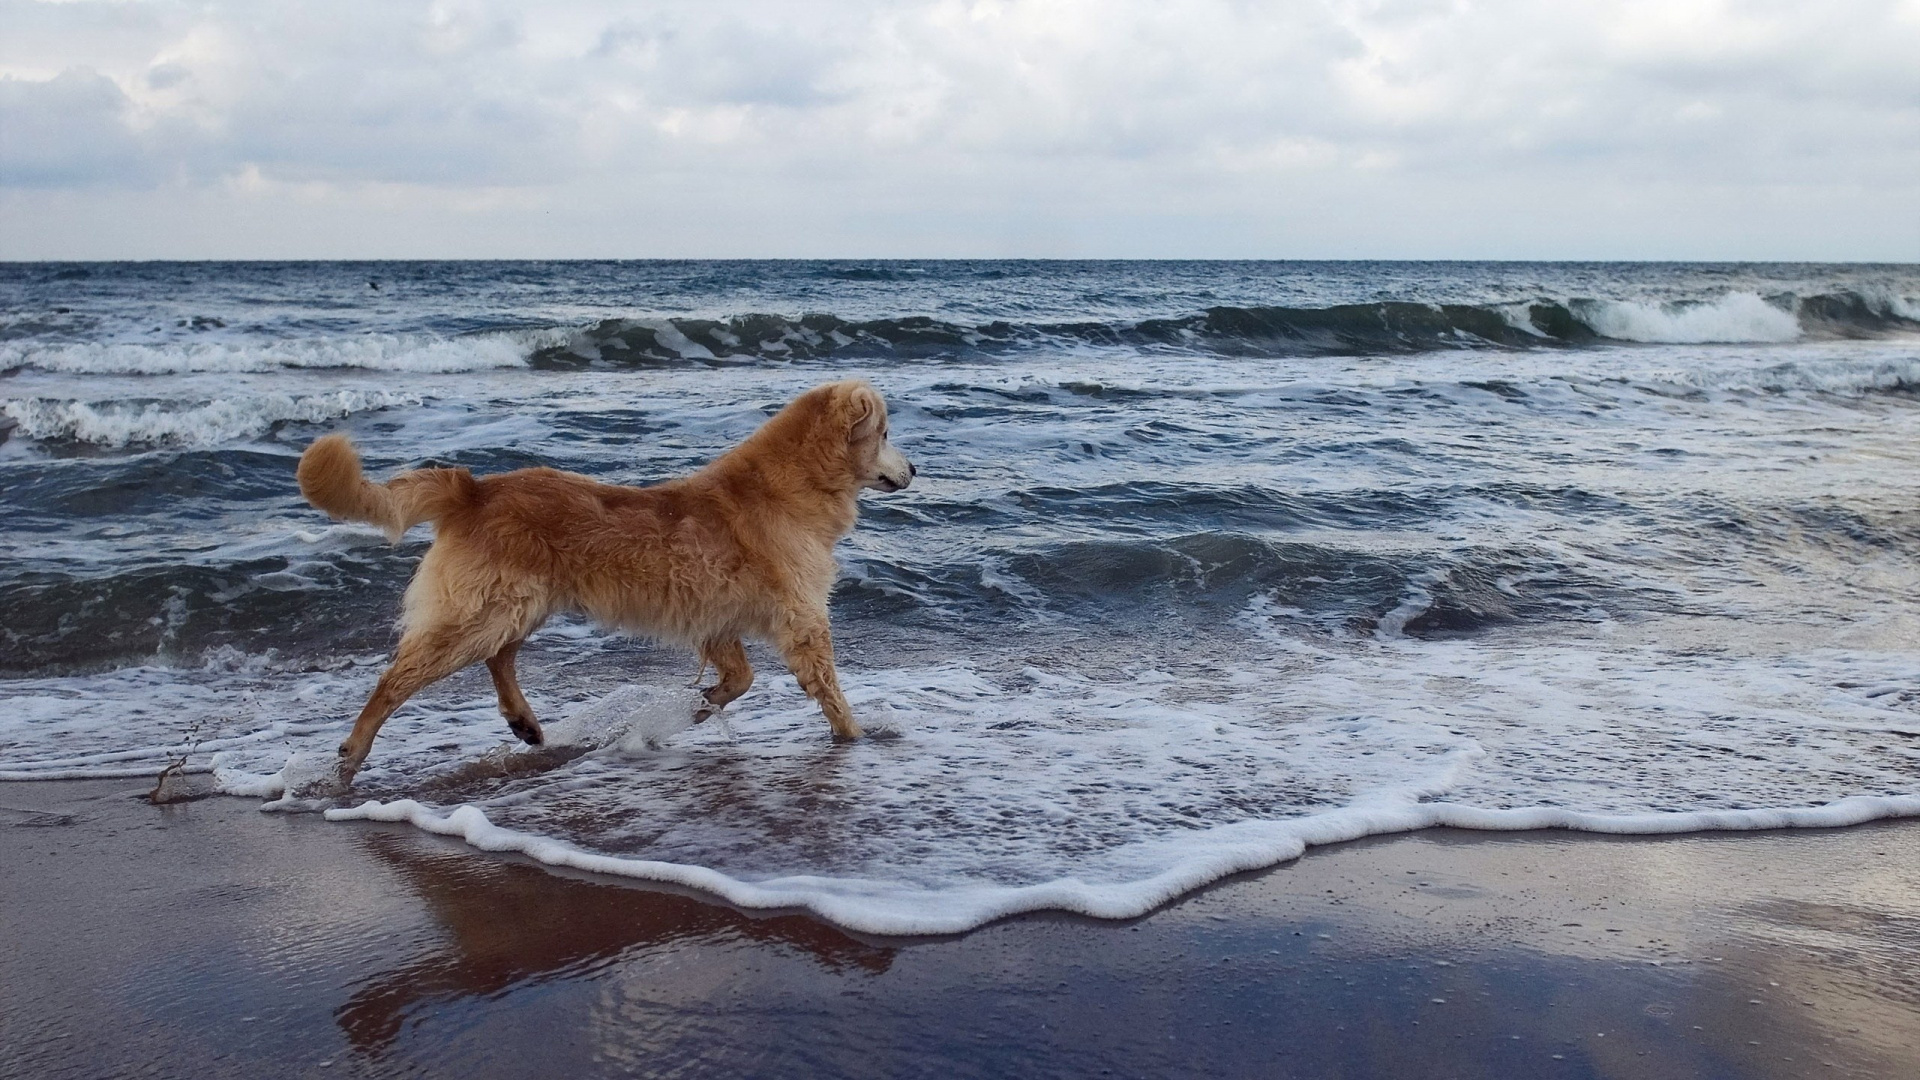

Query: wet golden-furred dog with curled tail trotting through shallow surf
<box><xmin>298</xmin><ymin>380</ymin><xmax>918</xmax><ymax>782</ymax></box>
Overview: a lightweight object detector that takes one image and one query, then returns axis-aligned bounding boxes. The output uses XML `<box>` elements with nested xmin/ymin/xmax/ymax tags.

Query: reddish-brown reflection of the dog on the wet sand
<box><xmin>334</xmin><ymin>832</ymin><xmax>895</xmax><ymax>1053</ymax></box>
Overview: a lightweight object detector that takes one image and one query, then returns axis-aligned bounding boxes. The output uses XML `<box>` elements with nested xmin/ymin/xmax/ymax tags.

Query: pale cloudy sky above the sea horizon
<box><xmin>0</xmin><ymin>0</ymin><xmax>1920</xmax><ymax>261</ymax></box>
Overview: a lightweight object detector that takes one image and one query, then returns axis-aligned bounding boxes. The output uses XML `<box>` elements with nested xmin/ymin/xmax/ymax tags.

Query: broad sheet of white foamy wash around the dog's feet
<box><xmin>0</xmin><ymin>614</ymin><xmax>1896</xmax><ymax>934</ymax></box>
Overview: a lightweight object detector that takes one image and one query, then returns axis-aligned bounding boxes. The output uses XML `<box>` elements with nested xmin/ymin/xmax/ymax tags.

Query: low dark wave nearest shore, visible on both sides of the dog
<box><xmin>0</xmin><ymin>526</ymin><xmax>1605</xmax><ymax>675</ymax></box>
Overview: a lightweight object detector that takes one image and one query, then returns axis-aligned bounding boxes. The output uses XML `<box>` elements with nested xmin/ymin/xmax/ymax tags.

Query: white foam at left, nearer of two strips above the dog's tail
<box><xmin>0</xmin><ymin>390</ymin><xmax>422</xmax><ymax>448</ymax></box>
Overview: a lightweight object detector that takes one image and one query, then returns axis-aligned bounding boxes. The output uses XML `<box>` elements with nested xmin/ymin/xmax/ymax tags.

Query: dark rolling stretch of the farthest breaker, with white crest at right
<box><xmin>530</xmin><ymin>292</ymin><xmax>1920</xmax><ymax>369</ymax></box>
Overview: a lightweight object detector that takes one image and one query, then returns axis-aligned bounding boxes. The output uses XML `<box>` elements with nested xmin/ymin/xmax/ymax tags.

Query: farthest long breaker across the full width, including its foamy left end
<box><xmin>0</xmin><ymin>290</ymin><xmax>1920</xmax><ymax>375</ymax></box>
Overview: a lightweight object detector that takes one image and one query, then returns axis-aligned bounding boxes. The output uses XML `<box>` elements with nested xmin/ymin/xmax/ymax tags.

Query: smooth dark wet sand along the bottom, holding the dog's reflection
<box><xmin>0</xmin><ymin>780</ymin><xmax>1920</xmax><ymax>1080</ymax></box>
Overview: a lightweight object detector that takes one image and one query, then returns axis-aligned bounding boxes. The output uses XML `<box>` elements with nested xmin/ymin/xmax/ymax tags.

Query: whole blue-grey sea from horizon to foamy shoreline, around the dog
<box><xmin>0</xmin><ymin>261</ymin><xmax>1920</xmax><ymax>934</ymax></box>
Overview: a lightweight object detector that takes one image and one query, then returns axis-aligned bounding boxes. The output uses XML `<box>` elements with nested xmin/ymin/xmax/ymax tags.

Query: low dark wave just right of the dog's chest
<box><xmin>835</xmin><ymin>530</ymin><xmax>1651</xmax><ymax>638</ymax></box>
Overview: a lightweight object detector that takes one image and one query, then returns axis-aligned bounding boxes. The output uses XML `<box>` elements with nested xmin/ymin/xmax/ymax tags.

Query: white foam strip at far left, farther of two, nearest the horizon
<box><xmin>0</xmin><ymin>331</ymin><xmax>541</xmax><ymax>375</ymax></box>
